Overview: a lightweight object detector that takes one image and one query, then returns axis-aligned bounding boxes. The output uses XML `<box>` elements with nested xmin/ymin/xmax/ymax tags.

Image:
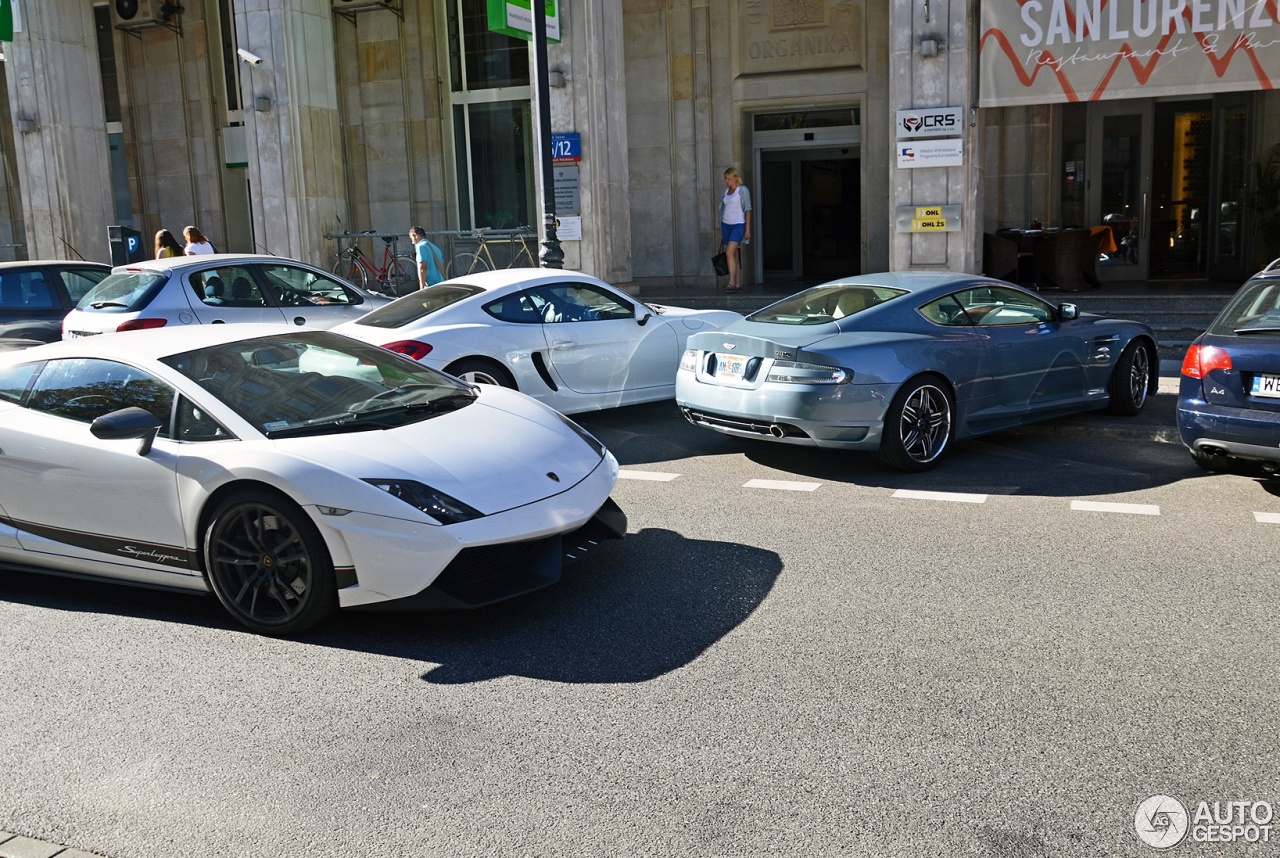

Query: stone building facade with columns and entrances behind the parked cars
<box><xmin>0</xmin><ymin>0</ymin><xmax>1280</xmax><ymax>287</ymax></box>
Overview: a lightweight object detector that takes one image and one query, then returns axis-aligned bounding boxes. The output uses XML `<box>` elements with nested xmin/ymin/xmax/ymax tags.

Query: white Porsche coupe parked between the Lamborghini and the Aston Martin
<box><xmin>334</xmin><ymin>268</ymin><xmax>742</xmax><ymax>414</ymax></box>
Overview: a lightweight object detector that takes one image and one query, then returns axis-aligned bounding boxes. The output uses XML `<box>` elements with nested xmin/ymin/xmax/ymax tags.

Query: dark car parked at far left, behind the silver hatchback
<box><xmin>0</xmin><ymin>260</ymin><xmax>111</xmax><ymax>343</ymax></box>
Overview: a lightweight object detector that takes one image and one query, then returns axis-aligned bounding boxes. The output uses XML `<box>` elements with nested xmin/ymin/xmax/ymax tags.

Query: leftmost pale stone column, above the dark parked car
<box><xmin>5</xmin><ymin>0</ymin><xmax>114</xmax><ymax>263</ymax></box>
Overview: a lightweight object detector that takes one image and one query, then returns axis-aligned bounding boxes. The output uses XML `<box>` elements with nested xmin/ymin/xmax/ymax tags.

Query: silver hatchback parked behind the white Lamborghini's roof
<box><xmin>63</xmin><ymin>254</ymin><xmax>389</xmax><ymax>339</ymax></box>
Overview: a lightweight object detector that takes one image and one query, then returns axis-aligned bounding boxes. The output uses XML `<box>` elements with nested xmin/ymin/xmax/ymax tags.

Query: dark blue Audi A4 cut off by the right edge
<box><xmin>1178</xmin><ymin>259</ymin><xmax>1280</xmax><ymax>471</ymax></box>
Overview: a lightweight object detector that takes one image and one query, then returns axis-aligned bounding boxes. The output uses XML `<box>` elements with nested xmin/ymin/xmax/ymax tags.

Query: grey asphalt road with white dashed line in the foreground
<box><xmin>0</xmin><ymin>403</ymin><xmax>1280</xmax><ymax>858</ymax></box>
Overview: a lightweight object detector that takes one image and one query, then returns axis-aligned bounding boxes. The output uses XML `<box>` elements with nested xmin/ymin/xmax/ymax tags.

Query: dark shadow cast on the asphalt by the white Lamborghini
<box><xmin>314</xmin><ymin>528</ymin><xmax>782</xmax><ymax>685</ymax></box>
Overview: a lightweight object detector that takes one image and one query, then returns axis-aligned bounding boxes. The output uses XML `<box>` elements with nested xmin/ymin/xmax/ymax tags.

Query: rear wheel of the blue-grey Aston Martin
<box><xmin>879</xmin><ymin>375</ymin><xmax>955</xmax><ymax>471</ymax></box>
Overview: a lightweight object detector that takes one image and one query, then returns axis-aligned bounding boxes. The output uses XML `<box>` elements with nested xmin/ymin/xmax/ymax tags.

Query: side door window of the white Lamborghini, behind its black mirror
<box><xmin>27</xmin><ymin>357</ymin><xmax>174</xmax><ymax>438</ymax></box>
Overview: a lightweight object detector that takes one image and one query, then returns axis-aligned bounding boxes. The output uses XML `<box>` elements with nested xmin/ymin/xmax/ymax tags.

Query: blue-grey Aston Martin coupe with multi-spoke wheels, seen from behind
<box><xmin>676</xmin><ymin>273</ymin><xmax>1158</xmax><ymax>471</ymax></box>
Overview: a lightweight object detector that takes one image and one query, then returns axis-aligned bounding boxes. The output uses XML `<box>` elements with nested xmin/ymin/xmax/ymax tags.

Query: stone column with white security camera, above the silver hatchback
<box><xmin>236</xmin><ymin>0</ymin><xmax>343</xmax><ymax>260</ymax></box>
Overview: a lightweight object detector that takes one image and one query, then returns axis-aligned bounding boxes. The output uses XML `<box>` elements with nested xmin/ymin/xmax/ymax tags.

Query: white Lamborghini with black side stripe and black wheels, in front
<box><xmin>0</xmin><ymin>325</ymin><xmax>626</xmax><ymax>634</ymax></box>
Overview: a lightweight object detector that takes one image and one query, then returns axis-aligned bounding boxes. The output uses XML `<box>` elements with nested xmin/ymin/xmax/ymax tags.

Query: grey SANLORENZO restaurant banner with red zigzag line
<box><xmin>978</xmin><ymin>0</ymin><xmax>1280</xmax><ymax>108</ymax></box>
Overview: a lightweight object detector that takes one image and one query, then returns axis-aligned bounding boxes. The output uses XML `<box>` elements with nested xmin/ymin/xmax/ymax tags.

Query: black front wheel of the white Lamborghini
<box><xmin>204</xmin><ymin>490</ymin><xmax>338</xmax><ymax>635</ymax></box>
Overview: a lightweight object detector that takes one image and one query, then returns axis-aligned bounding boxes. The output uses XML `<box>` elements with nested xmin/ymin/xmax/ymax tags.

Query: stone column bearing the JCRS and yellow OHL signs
<box><xmin>887</xmin><ymin>0</ymin><xmax>982</xmax><ymax>271</ymax></box>
